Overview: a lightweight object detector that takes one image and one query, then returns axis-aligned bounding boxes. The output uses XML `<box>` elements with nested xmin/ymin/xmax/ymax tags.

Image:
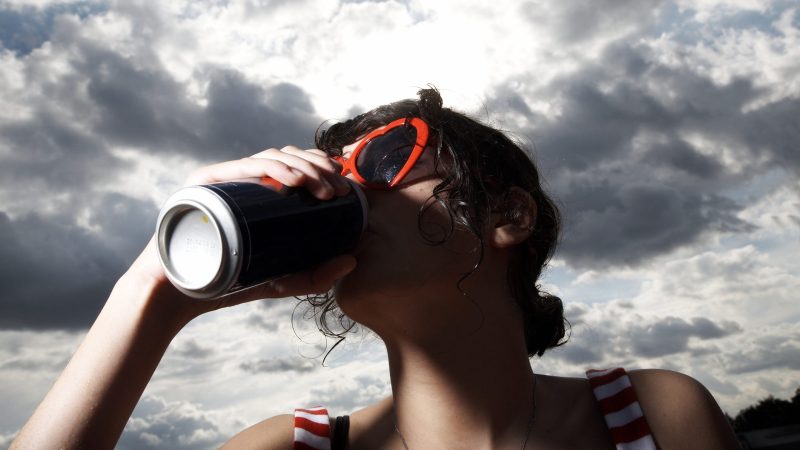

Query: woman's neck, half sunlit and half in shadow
<box><xmin>385</xmin><ymin>304</ymin><xmax>534</xmax><ymax>449</ymax></box>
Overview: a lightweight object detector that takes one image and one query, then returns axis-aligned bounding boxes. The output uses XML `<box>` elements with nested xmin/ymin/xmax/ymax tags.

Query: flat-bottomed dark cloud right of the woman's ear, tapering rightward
<box><xmin>558</xmin><ymin>182</ymin><xmax>754</xmax><ymax>266</ymax></box>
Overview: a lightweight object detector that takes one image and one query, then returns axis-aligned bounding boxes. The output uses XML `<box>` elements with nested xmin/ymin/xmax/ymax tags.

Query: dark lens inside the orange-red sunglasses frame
<box><xmin>356</xmin><ymin>126</ymin><xmax>417</xmax><ymax>186</ymax></box>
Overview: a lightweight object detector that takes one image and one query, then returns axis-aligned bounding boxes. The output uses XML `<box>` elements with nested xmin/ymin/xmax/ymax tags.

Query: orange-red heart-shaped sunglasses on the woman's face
<box><xmin>334</xmin><ymin>117</ymin><xmax>428</xmax><ymax>189</ymax></box>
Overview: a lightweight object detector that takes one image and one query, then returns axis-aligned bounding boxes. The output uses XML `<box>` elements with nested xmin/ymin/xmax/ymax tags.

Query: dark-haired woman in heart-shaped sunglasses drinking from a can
<box><xmin>12</xmin><ymin>89</ymin><xmax>738</xmax><ymax>449</ymax></box>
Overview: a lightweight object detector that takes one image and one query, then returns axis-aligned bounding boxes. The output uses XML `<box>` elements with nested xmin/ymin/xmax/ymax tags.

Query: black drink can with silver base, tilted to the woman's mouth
<box><xmin>156</xmin><ymin>182</ymin><xmax>367</xmax><ymax>298</ymax></box>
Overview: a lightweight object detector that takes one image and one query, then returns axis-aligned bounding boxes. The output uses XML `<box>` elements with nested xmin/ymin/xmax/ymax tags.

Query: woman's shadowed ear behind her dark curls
<box><xmin>489</xmin><ymin>186</ymin><xmax>536</xmax><ymax>248</ymax></box>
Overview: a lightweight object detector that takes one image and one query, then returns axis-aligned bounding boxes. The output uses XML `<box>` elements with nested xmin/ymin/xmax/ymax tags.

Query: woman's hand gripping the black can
<box><xmin>125</xmin><ymin>146</ymin><xmax>356</xmax><ymax>322</ymax></box>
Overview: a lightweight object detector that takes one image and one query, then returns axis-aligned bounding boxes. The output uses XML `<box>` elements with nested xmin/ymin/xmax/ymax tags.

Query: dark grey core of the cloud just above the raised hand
<box><xmin>76</xmin><ymin>44</ymin><xmax>321</xmax><ymax>161</ymax></box>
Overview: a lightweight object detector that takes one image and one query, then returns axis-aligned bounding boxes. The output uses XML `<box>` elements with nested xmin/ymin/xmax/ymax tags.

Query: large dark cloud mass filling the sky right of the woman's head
<box><xmin>489</xmin><ymin>40</ymin><xmax>800</xmax><ymax>267</ymax></box>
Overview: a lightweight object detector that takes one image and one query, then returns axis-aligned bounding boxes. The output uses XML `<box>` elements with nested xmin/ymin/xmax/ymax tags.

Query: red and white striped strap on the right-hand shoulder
<box><xmin>586</xmin><ymin>368</ymin><xmax>656</xmax><ymax>450</ymax></box>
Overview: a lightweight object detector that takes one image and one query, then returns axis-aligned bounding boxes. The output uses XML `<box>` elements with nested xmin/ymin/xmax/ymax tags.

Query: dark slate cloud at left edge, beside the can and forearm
<box><xmin>0</xmin><ymin>194</ymin><xmax>156</xmax><ymax>329</ymax></box>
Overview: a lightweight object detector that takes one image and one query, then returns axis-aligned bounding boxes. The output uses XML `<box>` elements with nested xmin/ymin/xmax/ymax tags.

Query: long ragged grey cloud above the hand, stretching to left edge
<box><xmin>4</xmin><ymin>15</ymin><xmax>321</xmax><ymax>163</ymax></box>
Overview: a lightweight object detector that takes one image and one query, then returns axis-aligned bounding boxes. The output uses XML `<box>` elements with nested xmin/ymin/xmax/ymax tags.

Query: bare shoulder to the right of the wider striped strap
<box><xmin>629</xmin><ymin>369</ymin><xmax>741</xmax><ymax>449</ymax></box>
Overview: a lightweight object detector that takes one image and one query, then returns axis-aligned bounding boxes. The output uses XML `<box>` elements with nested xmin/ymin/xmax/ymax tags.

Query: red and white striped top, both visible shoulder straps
<box><xmin>293</xmin><ymin>368</ymin><xmax>657</xmax><ymax>450</ymax></box>
